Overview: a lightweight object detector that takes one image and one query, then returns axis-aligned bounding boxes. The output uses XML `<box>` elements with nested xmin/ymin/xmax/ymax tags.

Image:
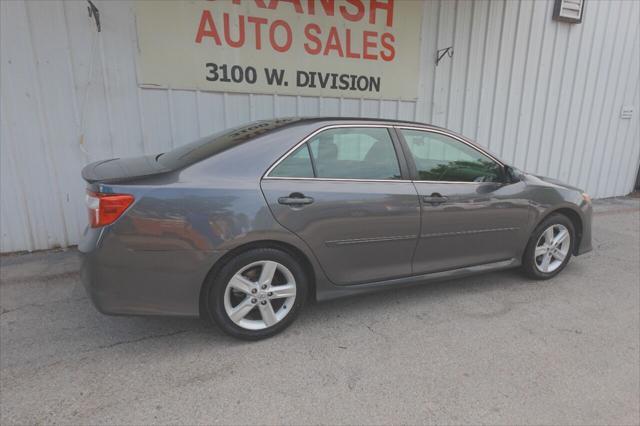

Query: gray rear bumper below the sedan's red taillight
<box><xmin>78</xmin><ymin>229</ymin><xmax>224</xmax><ymax>317</ymax></box>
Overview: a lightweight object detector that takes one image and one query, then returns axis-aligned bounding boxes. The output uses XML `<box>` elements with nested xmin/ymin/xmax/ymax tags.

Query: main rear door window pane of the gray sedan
<box><xmin>308</xmin><ymin>127</ymin><xmax>402</xmax><ymax>179</ymax></box>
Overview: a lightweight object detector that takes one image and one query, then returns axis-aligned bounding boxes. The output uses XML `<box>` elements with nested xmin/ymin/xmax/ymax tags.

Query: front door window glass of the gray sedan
<box><xmin>400</xmin><ymin>129</ymin><xmax>502</xmax><ymax>182</ymax></box>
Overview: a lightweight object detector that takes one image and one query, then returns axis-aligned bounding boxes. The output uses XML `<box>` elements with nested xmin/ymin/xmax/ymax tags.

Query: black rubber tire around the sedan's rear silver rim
<box><xmin>206</xmin><ymin>248</ymin><xmax>309</xmax><ymax>340</ymax></box>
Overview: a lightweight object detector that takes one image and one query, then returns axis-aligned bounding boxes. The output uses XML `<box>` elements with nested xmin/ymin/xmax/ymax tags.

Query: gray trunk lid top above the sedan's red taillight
<box><xmin>82</xmin><ymin>155</ymin><xmax>172</xmax><ymax>184</ymax></box>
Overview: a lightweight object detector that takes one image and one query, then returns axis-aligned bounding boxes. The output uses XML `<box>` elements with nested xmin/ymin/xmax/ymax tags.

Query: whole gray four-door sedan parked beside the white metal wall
<box><xmin>79</xmin><ymin>118</ymin><xmax>591</xmax><ymax>339</ymax></box>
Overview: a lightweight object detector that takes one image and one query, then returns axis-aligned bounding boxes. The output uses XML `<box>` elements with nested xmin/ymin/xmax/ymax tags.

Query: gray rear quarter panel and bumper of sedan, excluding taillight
<box><xmin>79</xmin><ymin>121</ymin><xmax>332</xmax><ymax>316</ymax></box>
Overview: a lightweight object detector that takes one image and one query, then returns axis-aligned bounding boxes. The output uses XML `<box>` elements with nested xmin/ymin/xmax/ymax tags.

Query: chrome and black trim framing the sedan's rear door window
<box><xmin>262</xmin><ymin>124</ymin><xmax>411</xmax><ymax>183</ymax></box>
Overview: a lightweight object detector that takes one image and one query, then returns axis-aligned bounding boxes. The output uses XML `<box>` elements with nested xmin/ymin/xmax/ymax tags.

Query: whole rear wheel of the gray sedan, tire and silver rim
<box><xmin>208</xmin><ymin>248</ymin><xmax>308</xmax><ymax>340</ymax></box>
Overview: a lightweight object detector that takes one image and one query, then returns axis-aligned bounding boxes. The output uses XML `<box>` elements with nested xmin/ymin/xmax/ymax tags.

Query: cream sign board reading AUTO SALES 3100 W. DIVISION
<box><xmin>136</xmin><ymin>0</ymin><xmax>423</xmax><ymax>100</ymax></box>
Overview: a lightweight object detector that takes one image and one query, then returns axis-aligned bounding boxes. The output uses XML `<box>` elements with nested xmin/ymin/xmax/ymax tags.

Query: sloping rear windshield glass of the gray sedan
<box><xmin>156</xmin><ymin>119</ymin><xmax>302</xmax><ymax>169</ymax></box>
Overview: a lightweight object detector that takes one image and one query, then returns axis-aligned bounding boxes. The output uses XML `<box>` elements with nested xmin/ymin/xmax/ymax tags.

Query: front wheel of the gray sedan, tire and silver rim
<box><xmin>522</xmin><ymin>214</ymin><xmax>575</xmax><ymax>280</ymax></box>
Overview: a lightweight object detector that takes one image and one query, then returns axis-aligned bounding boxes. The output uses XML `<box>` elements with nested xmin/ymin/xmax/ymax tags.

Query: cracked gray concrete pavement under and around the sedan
<box><xmin>0</xmin><ymin>199</ymin><xmax>640</xmax><ymax>425</ymax></box>
